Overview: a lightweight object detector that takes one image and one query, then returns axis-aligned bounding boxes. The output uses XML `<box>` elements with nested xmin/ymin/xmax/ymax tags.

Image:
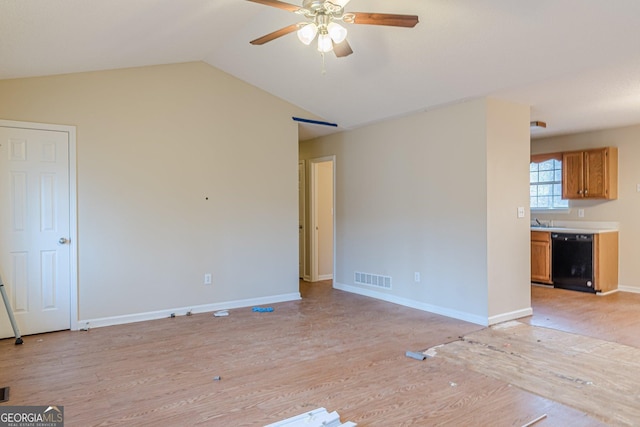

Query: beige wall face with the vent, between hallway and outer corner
<box><xmin>300</xmin><ymin>99</ymin><xmax>490</xmax><ymax>324</ymax></box>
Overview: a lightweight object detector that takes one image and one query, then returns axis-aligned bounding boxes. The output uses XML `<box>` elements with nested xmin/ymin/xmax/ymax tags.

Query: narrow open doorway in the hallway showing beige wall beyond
<box><xmin>309</xmin><ymin>156</ymin><xmax>335</xmax><ymax>282</ymax></box>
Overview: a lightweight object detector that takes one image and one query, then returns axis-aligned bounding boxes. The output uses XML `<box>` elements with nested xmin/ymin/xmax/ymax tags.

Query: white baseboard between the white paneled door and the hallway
<box><xmin>76</xmin><ymin>292</ymin><xmax>301</xmax><ymax>330</ymax></box>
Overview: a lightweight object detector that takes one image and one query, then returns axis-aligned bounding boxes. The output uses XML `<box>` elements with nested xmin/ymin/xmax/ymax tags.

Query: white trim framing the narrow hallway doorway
<box><xmin>309</xmin><ymin>155</ymin><xmax>336</xmax><ymax>282</ymax></box>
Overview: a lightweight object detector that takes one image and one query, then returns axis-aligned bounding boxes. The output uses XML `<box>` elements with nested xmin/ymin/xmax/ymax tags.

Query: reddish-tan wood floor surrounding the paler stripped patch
<box><xmin>0</xmin><ymin>282</ymin><xmax>640</xmax><ymax>427</ymax></box>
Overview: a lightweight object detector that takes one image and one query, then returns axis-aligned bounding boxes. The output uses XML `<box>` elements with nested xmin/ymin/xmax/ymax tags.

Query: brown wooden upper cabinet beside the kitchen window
<box><xmin>562</xmin><ymin>147</ymin><xmax>618</xmax><ymax>199</ymax></box>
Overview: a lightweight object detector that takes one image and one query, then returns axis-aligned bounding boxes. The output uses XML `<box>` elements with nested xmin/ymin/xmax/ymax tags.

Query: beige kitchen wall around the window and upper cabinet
<box><xmin>531</xmin><ymin>126</ymin><xmax>640</xmax><ymax>292</ymax></box>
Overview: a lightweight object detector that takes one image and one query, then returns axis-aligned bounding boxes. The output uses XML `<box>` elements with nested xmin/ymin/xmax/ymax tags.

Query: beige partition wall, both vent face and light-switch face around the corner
<box><xmin>300</xmin><ymin>99</ymin><xmax>530</xmax><ymax>324</ymax></box>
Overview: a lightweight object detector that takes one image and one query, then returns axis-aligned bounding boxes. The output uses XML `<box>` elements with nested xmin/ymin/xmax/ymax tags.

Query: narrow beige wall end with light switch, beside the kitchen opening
<box><xmin>487</xmin><ymin>98</ymin><xmax>532</xmax><ymax>324</ymax></box>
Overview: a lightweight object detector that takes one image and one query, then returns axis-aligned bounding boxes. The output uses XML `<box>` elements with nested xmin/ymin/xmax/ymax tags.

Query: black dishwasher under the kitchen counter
<box><xmin>551</xmin><ymin>233</ymin><xmax>596</xmax><ymax>293</ymax></box>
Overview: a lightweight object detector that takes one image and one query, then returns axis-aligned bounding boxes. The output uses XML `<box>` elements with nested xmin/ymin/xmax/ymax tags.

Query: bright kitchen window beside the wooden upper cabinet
<box><xmin>529</xmin><ymin>153</ymin><xmax>569</xmax><ymax>210</ymax></box>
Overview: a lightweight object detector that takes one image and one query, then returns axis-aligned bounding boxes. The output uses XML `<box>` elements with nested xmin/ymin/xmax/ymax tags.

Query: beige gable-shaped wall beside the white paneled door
<box><xmin>0</xmin><ymin>63</ymin><xmax>305</xmax><ymax>320</ymax></box>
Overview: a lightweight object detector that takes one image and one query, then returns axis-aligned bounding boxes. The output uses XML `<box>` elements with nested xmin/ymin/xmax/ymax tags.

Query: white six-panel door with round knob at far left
<box><xmin>0</xmin><ymin>126</ymin><xmax>71</xmax><ymax>338</ymax></box>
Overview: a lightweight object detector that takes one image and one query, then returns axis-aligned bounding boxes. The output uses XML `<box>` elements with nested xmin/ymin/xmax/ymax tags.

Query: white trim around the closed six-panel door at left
<box><xmin>0</xmin><ymin>119</ymin><xmax>78</xmax><ymax>331</ymax></box>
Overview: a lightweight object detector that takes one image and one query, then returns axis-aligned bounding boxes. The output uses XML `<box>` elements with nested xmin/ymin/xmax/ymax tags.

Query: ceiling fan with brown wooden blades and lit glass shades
<box><xmin>247</xmin><ymin>0</ymin><xmax>418</xmax><ymax>58</ymax></box>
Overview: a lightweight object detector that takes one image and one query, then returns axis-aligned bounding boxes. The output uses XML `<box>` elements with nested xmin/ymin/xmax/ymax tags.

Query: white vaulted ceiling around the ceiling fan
<box><xmin>0</xmin><ymin>0</ymin><xmax>640</xmax><ymax>137</ymax></box>
